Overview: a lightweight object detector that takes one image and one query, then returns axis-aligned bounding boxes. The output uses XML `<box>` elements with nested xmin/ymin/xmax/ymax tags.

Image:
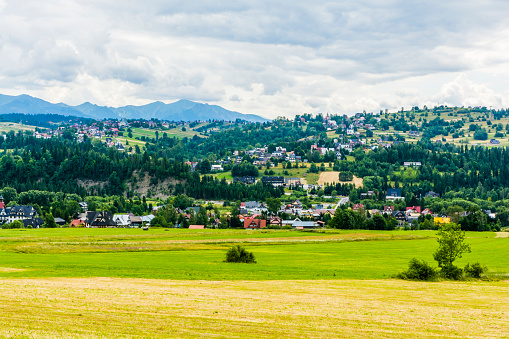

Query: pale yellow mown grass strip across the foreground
<box><xmin>0</xmin><ymin>278</ymin><xmax>509</xmax><ymax>338</ymax></box>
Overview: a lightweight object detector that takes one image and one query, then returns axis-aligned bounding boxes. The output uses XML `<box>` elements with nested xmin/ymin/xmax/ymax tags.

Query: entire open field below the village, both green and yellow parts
<box><xmin>0</xmin><ymin>229</ymin><xmax>509</xmax><ymax>338</ymax></box>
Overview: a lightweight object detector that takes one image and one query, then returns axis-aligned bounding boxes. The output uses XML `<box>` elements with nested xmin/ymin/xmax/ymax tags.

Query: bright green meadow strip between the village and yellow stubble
<box><xmin>0</xmin><ymin>229</ymin><xmax>509</xmax><ymax>280</ymax></box>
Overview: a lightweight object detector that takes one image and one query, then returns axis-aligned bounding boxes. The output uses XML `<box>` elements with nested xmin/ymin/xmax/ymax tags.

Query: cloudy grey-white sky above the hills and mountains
<box><xmin>0</xmin><ymin>0</ymin><xmax>509</xmax><ymax>118</ymax></box>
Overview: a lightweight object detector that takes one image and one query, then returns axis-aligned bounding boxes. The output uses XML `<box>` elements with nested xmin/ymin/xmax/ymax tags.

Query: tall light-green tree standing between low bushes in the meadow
<box><xmin>433</xmin><ymin>223</ymin><xmax>471</xmax><ymax>278</ymax></box>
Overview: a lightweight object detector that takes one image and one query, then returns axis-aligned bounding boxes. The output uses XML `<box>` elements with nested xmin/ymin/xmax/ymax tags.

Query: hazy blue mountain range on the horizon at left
<box><xmin>0</xmin><ymin>94</ymin><xmax>268</xmax><ymax>122</ymax></box>
